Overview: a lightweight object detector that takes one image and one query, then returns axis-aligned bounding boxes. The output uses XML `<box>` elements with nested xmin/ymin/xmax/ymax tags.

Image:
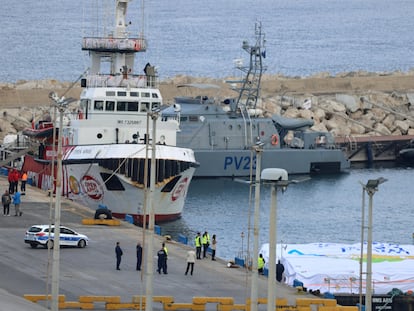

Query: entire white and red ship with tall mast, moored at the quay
<box><xmin>23</xmin><ymin>0</ymin><xmax>198</xmax><ymax>222</ymax></box>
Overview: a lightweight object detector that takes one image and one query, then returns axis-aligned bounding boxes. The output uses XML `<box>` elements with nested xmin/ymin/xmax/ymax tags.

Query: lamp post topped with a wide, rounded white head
<box><xmin>261</xmin><ymin>168</ymin><xmax>289</xmax><ymax>311</ymax></box>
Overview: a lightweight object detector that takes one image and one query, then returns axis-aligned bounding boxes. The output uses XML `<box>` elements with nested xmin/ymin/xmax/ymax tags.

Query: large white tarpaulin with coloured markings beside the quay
<box><xmin>259</xmin><ymin>242</ymin><xmax>414</xmax><ymax>294</ymax></box>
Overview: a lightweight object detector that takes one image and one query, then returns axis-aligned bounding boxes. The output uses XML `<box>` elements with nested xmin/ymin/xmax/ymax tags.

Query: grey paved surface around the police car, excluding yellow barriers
<box><xmin>0</xmin><ymin>176</ymin><xmax>303</xmax><ymax>310</ymax></box>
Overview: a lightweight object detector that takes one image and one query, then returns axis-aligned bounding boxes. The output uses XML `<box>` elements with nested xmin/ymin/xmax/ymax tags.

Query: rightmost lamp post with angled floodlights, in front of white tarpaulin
<box><xmin>362</xmin><ymin>177</ymin><xmax>387</xmax><ymax>311</ymax></box>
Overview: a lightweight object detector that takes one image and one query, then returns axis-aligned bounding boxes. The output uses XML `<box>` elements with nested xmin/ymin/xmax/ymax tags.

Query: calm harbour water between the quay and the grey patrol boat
<box><xmin>161</xmin><ymin>168</ymin><xmax>414</xmax><ymax>259</ymax></box>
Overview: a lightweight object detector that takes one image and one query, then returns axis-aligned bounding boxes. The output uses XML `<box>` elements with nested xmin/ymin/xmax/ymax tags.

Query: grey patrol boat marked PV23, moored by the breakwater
<box><xmin>162</xmin><ymin>23</ymin><xmax>350</xmax><ymax>177</ymax></box>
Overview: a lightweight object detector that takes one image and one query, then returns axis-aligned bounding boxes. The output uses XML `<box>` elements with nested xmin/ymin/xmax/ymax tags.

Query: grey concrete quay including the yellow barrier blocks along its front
<box><xmin>0</xmin><ymin>176</ymin><xmax>358</xmax><ymax>311</ymax></box>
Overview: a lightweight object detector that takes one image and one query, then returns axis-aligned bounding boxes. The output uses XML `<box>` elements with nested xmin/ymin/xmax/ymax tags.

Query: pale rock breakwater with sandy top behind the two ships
<box><xmin>0</xmin><ymin>72</ymin><xmax>414</xmax><ymax>141</ymax></box>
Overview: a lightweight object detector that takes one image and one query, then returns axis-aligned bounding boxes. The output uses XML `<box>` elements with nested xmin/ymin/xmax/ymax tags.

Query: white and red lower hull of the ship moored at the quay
<box><xmin>23</xmin><ymin>145</ymin><xmax>195</xmax><ymax>223</ymax></box>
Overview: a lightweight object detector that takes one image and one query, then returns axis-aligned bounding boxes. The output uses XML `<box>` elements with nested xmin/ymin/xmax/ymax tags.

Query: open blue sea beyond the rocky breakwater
<box><xmin>0</xmin><ymin>0</ymin><xmax>414</xmax><ymax>82</ymax></box>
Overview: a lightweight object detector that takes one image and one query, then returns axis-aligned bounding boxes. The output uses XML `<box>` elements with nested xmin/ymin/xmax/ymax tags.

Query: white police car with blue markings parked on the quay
<box><xmin>24</xmin><ymin>225</ymin><xmax>89</xmax><ymax>248</ymax></box>
